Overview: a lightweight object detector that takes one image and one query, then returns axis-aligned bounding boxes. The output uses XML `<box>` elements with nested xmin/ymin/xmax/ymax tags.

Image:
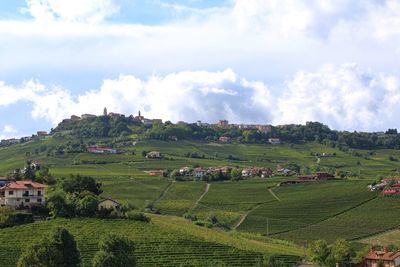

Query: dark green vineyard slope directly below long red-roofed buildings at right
<box><xmin>239</xmin><ymin>181</ymin><xmax>376</xmax><ymax>234</ymax></box>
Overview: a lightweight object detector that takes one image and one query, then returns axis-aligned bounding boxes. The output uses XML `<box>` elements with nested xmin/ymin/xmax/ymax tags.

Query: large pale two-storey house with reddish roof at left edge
<box><xmin>0</xmin><ymin>181</ymin><xmax>47</xmax><ymax>208</ymax></box>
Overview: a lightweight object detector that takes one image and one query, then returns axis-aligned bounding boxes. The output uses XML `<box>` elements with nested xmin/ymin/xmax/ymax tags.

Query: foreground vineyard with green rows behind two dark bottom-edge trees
<box><xmin>0</xmin><ymin>217</ymin><xmax>301</xmax><ymax>267</ymax></box>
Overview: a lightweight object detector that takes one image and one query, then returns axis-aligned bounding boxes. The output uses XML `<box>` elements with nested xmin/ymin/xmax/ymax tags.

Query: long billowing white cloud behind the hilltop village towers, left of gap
<box><xmin>0</xmin><ymin>69</ymin><xmax>272</xmax><ymax>125</ymax></box>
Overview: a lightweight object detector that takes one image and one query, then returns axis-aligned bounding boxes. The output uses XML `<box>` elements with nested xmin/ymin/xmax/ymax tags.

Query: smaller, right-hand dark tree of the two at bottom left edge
<box><xmin>93</xmin><ymin>235</ymin><xmax>136</xmax><ymax>267</ymax></box>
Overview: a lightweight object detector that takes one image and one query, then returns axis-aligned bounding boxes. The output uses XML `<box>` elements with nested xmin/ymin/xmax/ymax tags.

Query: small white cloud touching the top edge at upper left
<box><xmin>24</xmin><ymin>0</ymin><xmax>119</xmax><ymax>23</ymax></box>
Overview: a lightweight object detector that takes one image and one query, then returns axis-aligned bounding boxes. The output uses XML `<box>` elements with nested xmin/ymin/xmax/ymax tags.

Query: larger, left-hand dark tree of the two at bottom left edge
<box><xmin>17</xmin><ymin>228</ymin><xmax>80</xmax><ymax>267</ymax></box>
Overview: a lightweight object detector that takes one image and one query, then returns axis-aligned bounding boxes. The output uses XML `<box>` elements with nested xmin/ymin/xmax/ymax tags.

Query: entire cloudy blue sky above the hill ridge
<box><xmin>0</xmin><ymin>0</ymin><xmax>400</xmax><ymax>139</ymax></box>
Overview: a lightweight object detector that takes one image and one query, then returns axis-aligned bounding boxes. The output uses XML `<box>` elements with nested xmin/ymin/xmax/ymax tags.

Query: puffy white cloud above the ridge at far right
<box><xmin>274</xmin><ymin>64</ymin><xmax>400</xmax><ymax>130</ymax></box>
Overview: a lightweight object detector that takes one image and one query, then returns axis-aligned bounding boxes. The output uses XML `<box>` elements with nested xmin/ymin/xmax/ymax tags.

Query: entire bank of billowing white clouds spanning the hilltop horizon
<box><xmin>0</xmin><ymin>64</ymin><xmax>400</xmax><ymax>131</ymax></box>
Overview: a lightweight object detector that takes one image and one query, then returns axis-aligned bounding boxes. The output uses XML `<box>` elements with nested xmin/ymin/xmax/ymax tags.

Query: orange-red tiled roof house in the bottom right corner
<box><xmin>362</xmin><ymin>248</ymin><xmax>400</xmax><ymax>267</ymax></box>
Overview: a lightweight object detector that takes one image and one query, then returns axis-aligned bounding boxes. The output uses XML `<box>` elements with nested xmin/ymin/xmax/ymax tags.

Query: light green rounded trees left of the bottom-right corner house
<box><xmin>310</xmin><ymin>239</ymin><xmax>356</xmax><ymax>267</ymax></box>
